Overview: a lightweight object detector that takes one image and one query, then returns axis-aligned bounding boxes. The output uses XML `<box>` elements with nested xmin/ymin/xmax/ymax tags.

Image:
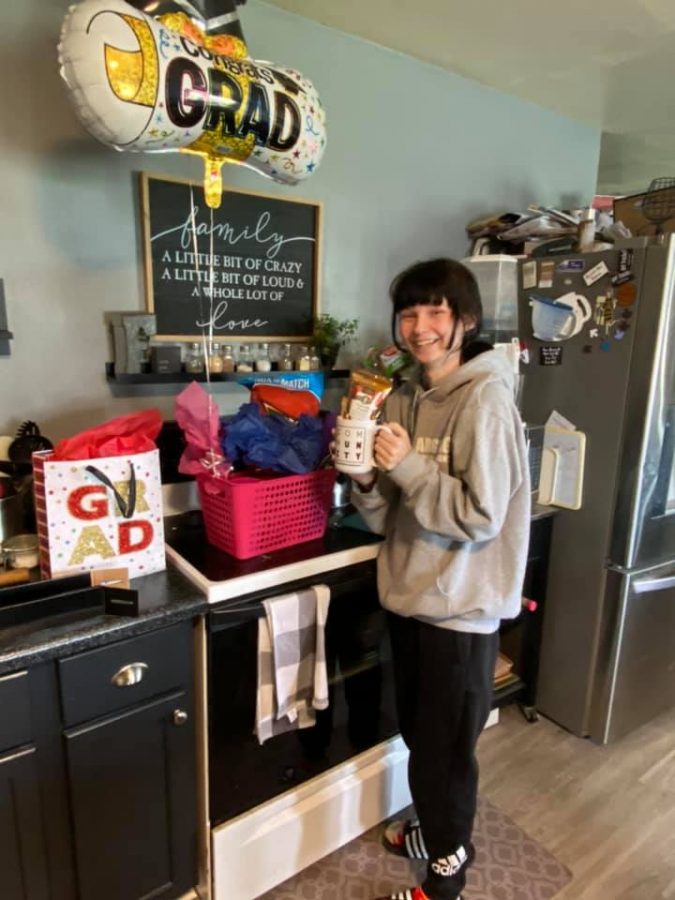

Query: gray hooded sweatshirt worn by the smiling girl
<box><xmin>352</xmin><ymin>350</ymin><xmax>530</xmax><ymax>633</ymax></box>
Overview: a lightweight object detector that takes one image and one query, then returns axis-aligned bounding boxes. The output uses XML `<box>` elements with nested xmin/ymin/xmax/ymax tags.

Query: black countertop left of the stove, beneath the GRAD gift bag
<box><xmin>0</xmin><ymin>568</ymin><xmax>208</xmax><ymax>675</ymax></box>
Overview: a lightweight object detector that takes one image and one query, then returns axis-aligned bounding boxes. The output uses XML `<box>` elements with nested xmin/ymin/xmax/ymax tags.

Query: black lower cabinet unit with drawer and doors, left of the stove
<box><xmin>0</xmin><ymin>621</ymin><xmax>197</xmax><ymax>900</ymax></box>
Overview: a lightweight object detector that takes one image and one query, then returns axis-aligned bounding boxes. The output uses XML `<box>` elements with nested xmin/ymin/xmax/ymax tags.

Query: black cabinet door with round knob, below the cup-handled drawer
<box><xmin>66</xmin><ymin>692</ymin><xmax>196</xmax><ymax>900</ymax></box>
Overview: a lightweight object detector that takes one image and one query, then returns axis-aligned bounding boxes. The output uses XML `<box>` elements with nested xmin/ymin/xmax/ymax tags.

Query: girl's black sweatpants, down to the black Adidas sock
<box><xmin>388</xmin><ymin>613</ymin><xmax>499</xmax><ymax>900</ymax></box>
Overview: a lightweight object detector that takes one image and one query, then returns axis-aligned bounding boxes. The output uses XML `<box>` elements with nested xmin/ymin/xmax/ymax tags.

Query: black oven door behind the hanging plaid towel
<box><xmin>208</xmin><ymin>561</ymin><xmax>398</xmax><ymax>826</ymax></box>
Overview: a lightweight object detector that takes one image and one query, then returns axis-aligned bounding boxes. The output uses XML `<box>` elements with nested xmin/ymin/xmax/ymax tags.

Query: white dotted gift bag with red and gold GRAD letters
<box><xmin>33</xmin><ymin>450</ymin><xmax>166</xmax><ymax>578</ymax></box>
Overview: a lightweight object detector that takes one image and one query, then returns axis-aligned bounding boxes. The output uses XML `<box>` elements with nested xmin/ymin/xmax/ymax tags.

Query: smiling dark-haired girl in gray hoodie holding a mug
<box><xmin>352</xmin><ymin>259</ymin><xmax>530</xmax><ymax>900</ymax></box>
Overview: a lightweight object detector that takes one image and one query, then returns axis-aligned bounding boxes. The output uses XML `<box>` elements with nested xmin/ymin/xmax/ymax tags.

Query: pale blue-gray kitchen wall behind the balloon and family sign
<box><xmin>0</xmin><ymin>0</ymin><xmax>600</xmax><ymax>439</ymax></box>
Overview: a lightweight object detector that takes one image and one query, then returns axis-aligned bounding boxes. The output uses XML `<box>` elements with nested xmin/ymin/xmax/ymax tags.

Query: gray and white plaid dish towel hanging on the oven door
<box><xmin>255</xmin><ymin>584</ymin><xmax>330</xmax><ymax>744</ymax></box>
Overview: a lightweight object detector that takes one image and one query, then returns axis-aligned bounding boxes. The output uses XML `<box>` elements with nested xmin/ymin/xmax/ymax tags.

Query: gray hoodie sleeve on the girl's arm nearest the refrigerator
<box><xmin>389</xmin><ymin>404</ymin><xmax>523</xmax><ymax>541</ymax></box>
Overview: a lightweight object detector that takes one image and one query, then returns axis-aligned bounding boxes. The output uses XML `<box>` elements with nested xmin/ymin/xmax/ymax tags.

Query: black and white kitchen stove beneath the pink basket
<box><xmin>164</xmin><ymin>508</ymin><xmax>410</xmax><ymax>900</ymax></box>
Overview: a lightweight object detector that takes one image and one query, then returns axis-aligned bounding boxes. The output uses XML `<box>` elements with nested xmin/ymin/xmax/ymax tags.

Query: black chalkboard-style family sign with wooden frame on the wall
<box><xmin>141</xmin><ymin>173</ymin><xmax>321</xmax><ymax>341</ymax></box>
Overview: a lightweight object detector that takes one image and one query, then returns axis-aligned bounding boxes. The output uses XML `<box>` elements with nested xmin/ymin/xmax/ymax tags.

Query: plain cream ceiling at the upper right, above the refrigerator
<box><xmin>268</xmin><ymin>0</ymin><xmax>675</xmax><ymax>193</ymax></box>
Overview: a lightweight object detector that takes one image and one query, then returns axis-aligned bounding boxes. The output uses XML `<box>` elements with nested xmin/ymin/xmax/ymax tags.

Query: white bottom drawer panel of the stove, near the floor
<box><xmin>211</xmin><ymin>737</ymin><xmax>410</xmax><ymax>900</ymax></box>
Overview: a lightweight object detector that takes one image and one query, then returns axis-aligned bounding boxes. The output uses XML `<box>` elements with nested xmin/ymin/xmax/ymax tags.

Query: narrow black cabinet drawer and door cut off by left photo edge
<box><xmin>0</xmin><ymin>671</ymin><xmax>49</xmax><ymax>900</ymax></box>
